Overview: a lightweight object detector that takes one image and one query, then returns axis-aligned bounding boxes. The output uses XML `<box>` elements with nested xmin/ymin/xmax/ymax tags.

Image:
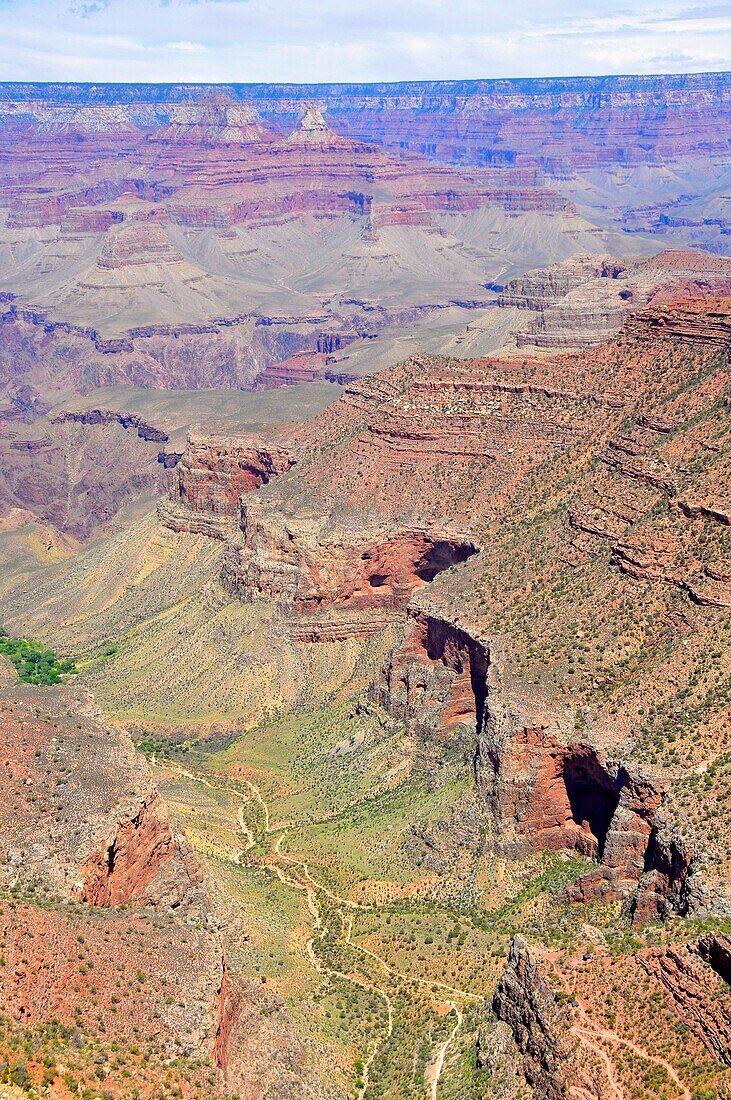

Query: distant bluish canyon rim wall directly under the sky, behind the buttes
<box><xmin>5</xmin><ymin>73</ymin><xmax>730</xmax><ymax>171</ymax></box>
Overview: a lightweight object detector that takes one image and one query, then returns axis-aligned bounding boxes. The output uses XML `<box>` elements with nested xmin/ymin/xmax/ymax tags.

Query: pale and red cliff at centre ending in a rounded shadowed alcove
<box><xmin>222</xmin><ymin>496</ymin><xmax>477</xmax><ymax>613</ymax></box>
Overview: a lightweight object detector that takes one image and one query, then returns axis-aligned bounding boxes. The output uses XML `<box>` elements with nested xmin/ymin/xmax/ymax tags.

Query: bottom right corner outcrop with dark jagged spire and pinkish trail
<box><xmin>488</xmin><ymin>935</ymin><xmax>731</xmax><ymax>1100</ymax></box>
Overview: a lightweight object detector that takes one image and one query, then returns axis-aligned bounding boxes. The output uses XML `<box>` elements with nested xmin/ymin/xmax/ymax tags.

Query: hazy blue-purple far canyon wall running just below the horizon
<box><xmin>3</xmin><ymin>73</ymin><xmax>731</xmax><ymax>169</ymax></box>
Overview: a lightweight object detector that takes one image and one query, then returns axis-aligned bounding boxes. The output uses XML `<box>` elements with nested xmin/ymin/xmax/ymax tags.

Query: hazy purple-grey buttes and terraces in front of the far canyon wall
<box><xmin>0</xmin><ymin>89</ymin><xmax>615</xmax><ymax>400</ymax></box>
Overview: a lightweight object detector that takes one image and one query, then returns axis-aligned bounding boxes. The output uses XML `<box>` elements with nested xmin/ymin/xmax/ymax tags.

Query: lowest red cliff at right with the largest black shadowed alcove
<box><xmin>475</xmin><ymin>691</ymin><xmax>708</xmax><ymax>924</ymax></box>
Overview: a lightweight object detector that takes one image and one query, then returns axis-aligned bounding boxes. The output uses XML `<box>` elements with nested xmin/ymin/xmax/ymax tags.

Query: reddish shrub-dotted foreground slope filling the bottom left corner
<box><xmin>0</xmin><ymin>666</ymin><xmax>335</xmax><ymax>1100</ymax></box>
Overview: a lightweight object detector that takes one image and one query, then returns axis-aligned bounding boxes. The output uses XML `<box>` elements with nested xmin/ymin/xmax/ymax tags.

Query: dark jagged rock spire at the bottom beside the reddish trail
<box><xmin>492</xmin><ymin>936</ymin><xmax>576</xmax><ymax>1100</ymax></box>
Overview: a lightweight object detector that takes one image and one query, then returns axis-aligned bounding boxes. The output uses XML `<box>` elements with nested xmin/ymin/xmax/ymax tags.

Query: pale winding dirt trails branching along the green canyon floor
<box><xmin>152</xmin><ymin>755</ymin><xmax>479</xmax><ymax>1100</ymax></box>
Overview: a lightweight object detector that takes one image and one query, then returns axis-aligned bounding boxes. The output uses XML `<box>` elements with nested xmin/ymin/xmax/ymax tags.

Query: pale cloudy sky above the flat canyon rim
<box><xmin>0</xmin><ymin>0</ymin><xmax>731</xmax><ymax>83</ymax></box>
